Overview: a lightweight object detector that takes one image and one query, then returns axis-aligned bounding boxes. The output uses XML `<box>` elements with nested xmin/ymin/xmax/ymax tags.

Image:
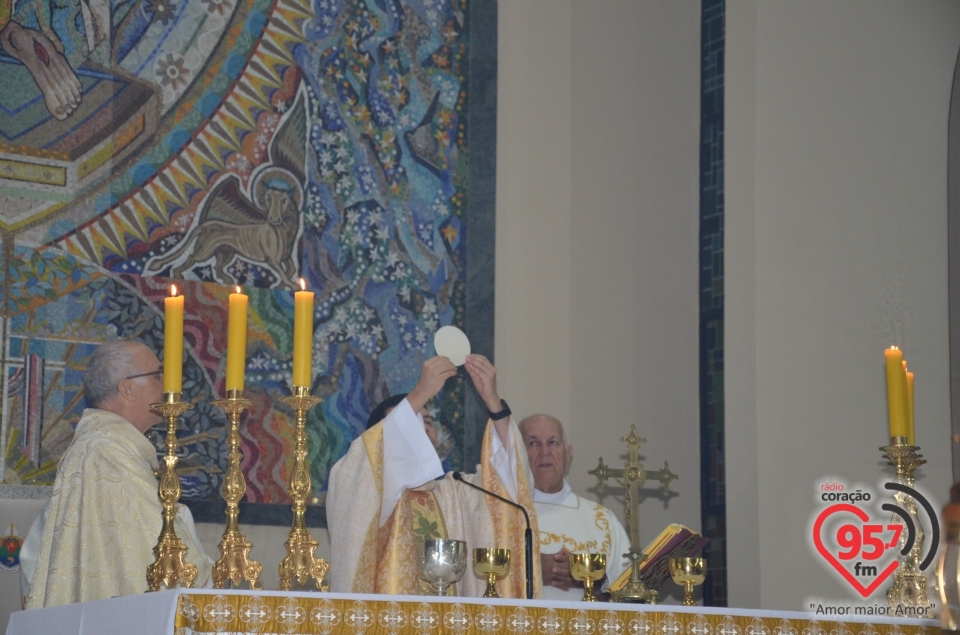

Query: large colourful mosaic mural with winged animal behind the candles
<box><xmin>0</xmin><ymin>0</ymin><xmax>496</xmax><ymax>522</ymax></box>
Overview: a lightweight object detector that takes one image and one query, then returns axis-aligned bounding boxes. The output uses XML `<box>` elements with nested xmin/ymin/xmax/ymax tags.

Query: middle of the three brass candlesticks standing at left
<box><xmin>213</xmin><ymin>390</ymin><xmax>263</xmax><ymax>590</ymax></box>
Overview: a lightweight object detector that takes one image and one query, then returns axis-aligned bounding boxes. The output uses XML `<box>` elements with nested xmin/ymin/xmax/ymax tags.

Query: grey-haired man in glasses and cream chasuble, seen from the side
<box><xmin>21</xmin><ymin>342</ymin><xmax>213</xmax><ymax>608</ymax></box>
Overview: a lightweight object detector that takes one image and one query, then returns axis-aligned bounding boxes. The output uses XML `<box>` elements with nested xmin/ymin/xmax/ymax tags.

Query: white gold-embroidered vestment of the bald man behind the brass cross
<box><xmin>533</xmin><ymin>481</ymin><xmax>630</xmax><ymax>602</ymax></box>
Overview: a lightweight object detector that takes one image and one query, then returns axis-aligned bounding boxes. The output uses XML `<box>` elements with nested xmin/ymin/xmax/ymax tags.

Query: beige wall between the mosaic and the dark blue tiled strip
<box><xmin>495</xmin><ymin>0</ymin><xmax>700</xmax><ymax>560</ymax></box>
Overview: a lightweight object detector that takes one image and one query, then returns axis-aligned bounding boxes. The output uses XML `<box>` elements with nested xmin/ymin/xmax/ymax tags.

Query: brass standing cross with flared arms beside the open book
<box><xmin>587</xmin><ymin>425</ymin><xmax>680</xmax><ymax>604</ymax></box>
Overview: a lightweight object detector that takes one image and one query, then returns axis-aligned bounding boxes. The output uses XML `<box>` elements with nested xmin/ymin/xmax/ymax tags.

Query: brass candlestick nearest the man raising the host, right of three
<box><xmin>280</xmin><ymin>386</ymin><xmax>330</xmax><ymax>591</ymax></box>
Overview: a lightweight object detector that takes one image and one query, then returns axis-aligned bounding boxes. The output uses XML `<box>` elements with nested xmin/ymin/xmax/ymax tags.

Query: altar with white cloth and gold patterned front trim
<box><xmin>7</xmin><ymin>589</ymin><xmax>939</xmax><ymax>635</ymax></box>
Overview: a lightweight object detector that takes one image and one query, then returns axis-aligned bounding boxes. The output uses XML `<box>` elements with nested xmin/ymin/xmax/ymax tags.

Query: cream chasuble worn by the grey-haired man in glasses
<box><xmin>26</xmin><ymin>408</ymin><xmax>213</xmax><ymax>609</ymax></box>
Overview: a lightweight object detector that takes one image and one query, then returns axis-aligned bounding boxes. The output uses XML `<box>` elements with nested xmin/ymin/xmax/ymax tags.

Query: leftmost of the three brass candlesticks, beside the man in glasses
<box><xmin>147</xmin><ymin>392</ymin><xmax>197</xmax><ymax>591</ymax></box>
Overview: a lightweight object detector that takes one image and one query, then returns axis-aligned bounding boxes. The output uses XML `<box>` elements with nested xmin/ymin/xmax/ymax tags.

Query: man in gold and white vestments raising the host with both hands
<box><xmin>327</xmin><ymin>355</ymin><xmax>540</xmax><ymax>598</ymax></box>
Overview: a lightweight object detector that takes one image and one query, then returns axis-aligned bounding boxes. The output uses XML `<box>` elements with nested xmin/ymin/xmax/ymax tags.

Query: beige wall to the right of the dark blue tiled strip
<box><xmin>725</xmin><ymin>0</ymin><xmax>960</xmax><ymax>610</ymax></box>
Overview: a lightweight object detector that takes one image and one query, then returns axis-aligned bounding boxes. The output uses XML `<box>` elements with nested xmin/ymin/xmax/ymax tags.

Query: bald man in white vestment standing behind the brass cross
<box><xmin>520</xmin><ymin>415</ymin><xmax>630</xmax><ymax>601</ymax></box>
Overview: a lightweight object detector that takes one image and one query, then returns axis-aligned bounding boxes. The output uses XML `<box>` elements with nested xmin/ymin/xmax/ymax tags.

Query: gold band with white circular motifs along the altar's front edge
<box><xmin>175</xmin><ymin>590</ymin><xmax>937</xmax><ymax>635</ymax></box>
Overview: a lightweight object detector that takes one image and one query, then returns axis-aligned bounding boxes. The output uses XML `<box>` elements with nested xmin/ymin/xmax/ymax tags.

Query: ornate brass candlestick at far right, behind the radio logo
<box><xmin>880</xmin><ymin>437</ymin><xmax>930</xmax><ymax>607</ymax></box>
